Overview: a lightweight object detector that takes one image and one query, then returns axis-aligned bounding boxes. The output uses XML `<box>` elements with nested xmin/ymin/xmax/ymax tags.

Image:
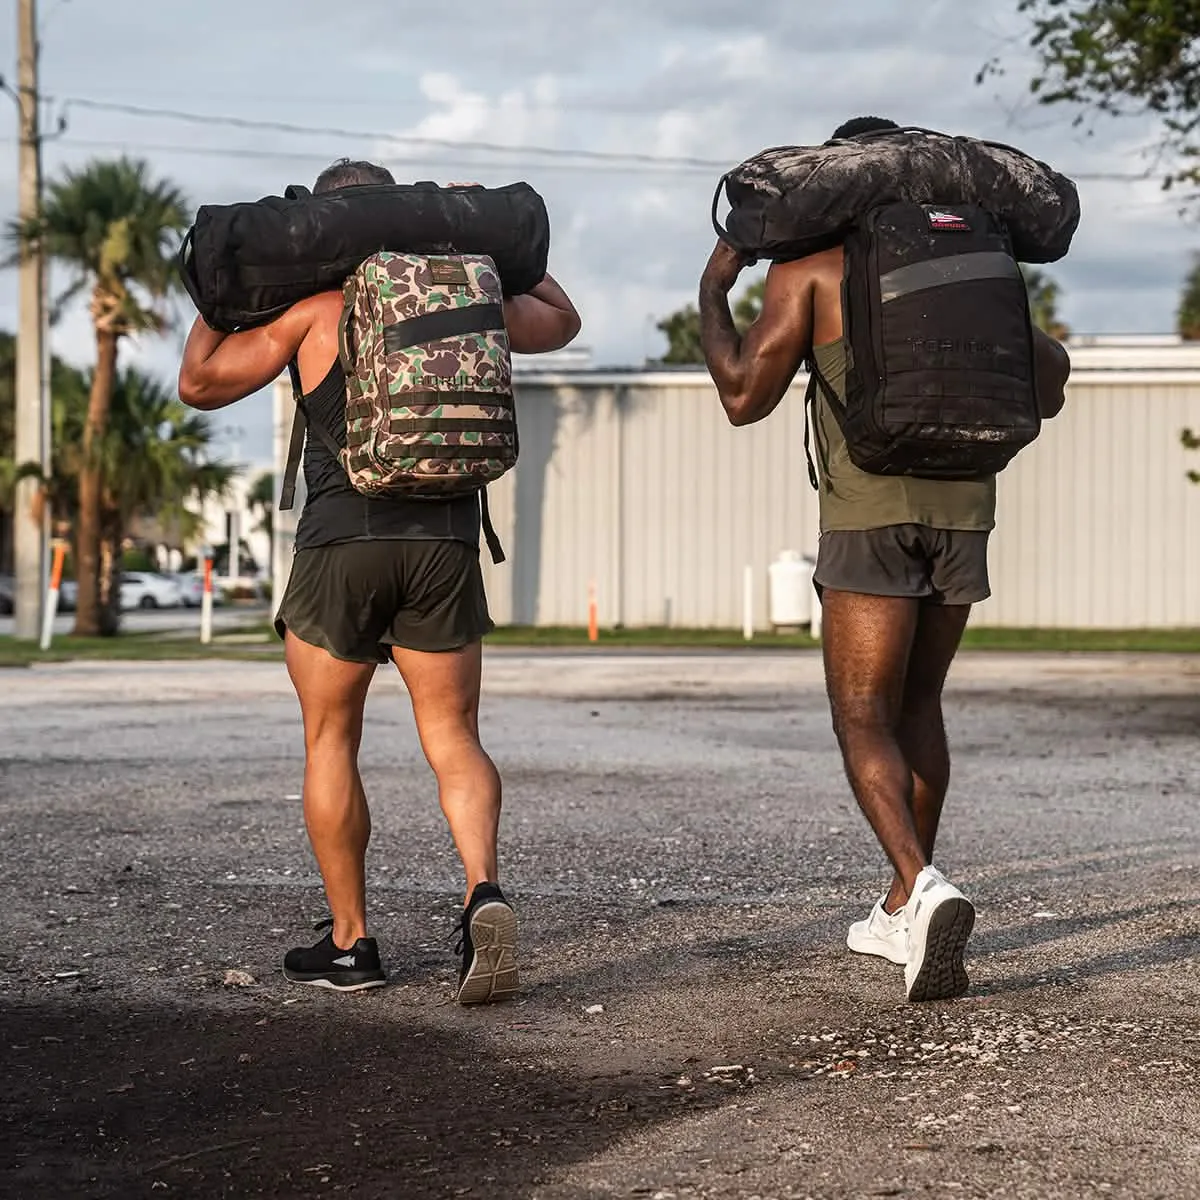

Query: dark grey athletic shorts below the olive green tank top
<box><xmin>812</xmin><ymin>524</ymin><xmax>991</xmax><ymax>605</ymax></box>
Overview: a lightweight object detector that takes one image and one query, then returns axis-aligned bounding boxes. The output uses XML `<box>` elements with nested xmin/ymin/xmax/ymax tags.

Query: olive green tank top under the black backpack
<box><xmin>812</xmin><ymin>338</ymin><xmax>996</xmax><ymax>533</ymax></box>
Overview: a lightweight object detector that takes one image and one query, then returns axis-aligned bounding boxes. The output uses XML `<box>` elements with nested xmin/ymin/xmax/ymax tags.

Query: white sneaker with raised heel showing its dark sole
<box><xmin>904</xmin><ymin>866</ymin><xmax>974</xmax><ymax>1001</ymax></box>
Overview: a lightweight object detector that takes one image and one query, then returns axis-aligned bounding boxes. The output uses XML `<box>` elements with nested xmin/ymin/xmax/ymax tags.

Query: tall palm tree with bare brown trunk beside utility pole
<box><xmin>10</xmin><ymin>158</ymin><xmax>188</xmax><ymax>635</ymax></box>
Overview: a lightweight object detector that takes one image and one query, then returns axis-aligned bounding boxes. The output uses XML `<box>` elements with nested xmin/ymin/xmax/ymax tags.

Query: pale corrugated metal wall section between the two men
<box><xmin>485</xmin><ymin>383</ymin><xmax>816</xmax><ymax>626</ymax></box>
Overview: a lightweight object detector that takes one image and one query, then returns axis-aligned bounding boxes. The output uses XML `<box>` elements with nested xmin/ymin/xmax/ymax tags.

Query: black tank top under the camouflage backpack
<box><xmin>295</xmin><ymin>362</ymin><xmax>480</xmax><ymax>550</ymax></box>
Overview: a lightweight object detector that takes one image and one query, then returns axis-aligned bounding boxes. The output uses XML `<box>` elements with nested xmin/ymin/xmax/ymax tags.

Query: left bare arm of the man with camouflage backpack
<box><xmin>179</xmin><ymin>298</ymin><xmax>326</xmax><ymax>410</ymax></box>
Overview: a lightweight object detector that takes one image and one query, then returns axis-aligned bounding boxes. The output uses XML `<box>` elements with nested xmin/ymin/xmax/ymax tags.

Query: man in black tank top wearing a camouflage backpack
<box><xmin>179</xmin><ymin>160</ymin><xmax>580</xmax><ymax>1004</ymax></box>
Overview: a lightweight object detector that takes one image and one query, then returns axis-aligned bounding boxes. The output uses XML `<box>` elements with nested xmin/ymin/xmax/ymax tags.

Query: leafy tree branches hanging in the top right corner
<box><xmin>979</xmin><ymin>0</ymin><xmax>1200</xmax><ymax>185</ymax></box>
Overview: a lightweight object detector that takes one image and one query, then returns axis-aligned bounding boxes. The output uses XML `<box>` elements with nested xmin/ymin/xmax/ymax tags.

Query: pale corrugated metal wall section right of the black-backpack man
<box><xmin>974</xmin><ymin>376</ymin><xmax>1200</xmax><ymax>629</ymax></box>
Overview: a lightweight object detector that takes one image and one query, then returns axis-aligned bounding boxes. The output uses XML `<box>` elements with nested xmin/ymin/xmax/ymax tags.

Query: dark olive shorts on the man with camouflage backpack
<box><xmin>275</xmin><ymin>539</ymin><xmax>496</xmax><ymax>662</ymax></box>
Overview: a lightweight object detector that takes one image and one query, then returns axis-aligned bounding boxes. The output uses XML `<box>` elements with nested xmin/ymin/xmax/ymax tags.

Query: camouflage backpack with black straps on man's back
<box><xmin>280</xmin><ymin>251</ymin><xmax>518</xmax><ymax>562</ymax></box>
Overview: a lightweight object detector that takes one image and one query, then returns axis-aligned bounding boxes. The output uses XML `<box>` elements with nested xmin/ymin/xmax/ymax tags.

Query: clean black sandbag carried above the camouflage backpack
<box><xmin>179</xmin><ymin>177</ymin><xmax>550</xmax><ymax>332</ymax></box>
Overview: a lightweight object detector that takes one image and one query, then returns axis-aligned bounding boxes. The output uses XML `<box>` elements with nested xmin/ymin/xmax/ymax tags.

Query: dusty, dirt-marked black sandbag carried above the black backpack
<box><xmin>713</xmin><ymin>128</ymin><xmax>1079</xmax><ymax>263</ymax></box>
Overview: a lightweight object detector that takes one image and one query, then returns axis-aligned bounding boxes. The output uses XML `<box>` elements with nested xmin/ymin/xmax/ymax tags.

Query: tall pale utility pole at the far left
<box><xmin>13</xmin><ymin>0</ymin><xmax>48</xmax><ymax>641</ymax></box>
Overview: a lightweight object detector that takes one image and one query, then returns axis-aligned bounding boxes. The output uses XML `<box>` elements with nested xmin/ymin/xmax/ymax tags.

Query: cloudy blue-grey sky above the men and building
<box><xmin>0</xmin><ymin>0</ymin><xmax>1185</xmax><ymax>458</ymax></box>
